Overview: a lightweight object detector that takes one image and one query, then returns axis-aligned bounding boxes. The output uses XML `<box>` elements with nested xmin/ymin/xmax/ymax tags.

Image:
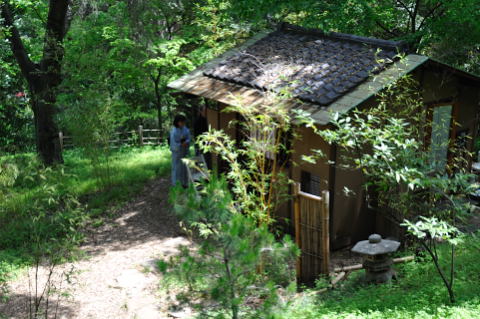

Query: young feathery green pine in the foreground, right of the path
<box><xmin>165</xmin><ymin>178</ymin><xmax>298</xmax><ymax>319</ymax></box>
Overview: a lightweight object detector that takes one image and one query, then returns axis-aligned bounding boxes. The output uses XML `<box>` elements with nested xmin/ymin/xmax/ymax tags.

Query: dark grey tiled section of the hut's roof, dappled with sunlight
<box><xmin>203</xmin><ymin>24</ymin><xmax>404</xmax><ymax>106</ymax></box>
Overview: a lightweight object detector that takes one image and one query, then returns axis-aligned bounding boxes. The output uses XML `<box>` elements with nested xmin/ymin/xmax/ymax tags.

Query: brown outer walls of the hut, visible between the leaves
<box><xmin>201</xmin><ymin>67</ymin><xmax>480</xmax><ymax>249</ymax></box>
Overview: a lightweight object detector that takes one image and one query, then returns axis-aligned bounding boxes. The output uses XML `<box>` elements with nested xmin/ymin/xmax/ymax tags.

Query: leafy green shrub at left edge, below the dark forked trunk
<box><xmin>0</xmin><ymin>156</ymin><xmax>84</xmax><ymax>254</ymax></box>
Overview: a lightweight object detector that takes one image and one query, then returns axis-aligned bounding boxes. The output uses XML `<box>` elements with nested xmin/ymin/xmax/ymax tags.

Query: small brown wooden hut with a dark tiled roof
<box><xmin>169</xmin><ymin>24</ymin><xmax>480</xmax><ymax>277</ymax></box>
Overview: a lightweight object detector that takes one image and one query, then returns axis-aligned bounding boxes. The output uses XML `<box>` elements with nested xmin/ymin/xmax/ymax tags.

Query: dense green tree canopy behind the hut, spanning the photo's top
<box><xmin>0</xmin><ymin>0</ymin><xmax>480</xmax><ymax>158</ymax></box>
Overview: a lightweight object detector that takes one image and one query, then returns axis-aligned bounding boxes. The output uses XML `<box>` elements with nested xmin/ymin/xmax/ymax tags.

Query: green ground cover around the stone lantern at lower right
<box><xmin>285</xmin><ymin>236</ymin><xmax>480</xmax><ymax>319</ymax></box>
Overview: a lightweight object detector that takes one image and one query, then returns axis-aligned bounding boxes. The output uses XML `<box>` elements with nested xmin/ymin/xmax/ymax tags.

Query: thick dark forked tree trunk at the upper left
<box><xmin>0</xmin><ymin>0</ymin><xmax>69</xmax><ymax>165</ymax></box>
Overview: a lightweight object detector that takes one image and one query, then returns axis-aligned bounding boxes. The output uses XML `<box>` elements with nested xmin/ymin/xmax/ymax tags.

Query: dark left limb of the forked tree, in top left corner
<box><xmin>0</xmin><ymin>1</ymin><xmax>36</xmax><ymax>80</ymax></box>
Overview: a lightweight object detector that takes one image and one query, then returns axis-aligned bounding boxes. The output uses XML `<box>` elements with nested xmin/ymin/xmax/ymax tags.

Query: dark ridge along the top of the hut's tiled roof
<box><xmin>278</xmin><ymin>22</ymin><xmax>408</xmax><ymax>52</ymax></box>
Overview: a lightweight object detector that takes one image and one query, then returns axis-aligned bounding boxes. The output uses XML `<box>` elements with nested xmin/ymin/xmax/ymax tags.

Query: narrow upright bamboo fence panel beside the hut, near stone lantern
<box><xmin>294</xmin><ymin>184</ymin><xmax>330</xmax><ymax>282</ymax></box>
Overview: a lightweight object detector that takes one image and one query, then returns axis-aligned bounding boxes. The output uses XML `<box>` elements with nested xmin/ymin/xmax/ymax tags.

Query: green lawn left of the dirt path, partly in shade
<box><xmin>0</xmin><ymin>146</ymin><xmax>170</xmax><ymax>286</ymax></box>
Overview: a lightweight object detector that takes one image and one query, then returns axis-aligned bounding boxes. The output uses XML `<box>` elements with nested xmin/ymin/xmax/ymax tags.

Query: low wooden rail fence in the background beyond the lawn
<box><xmin>58</xmin><ymin>125</ymin><xmax>163</xmax><ymax>150</ymax></box>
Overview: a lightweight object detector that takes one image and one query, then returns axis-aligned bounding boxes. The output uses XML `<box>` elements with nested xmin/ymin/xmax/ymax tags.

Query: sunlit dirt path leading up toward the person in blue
<box><xmin>0</xmin><ymin>178</ymin><xmax>189</xmax><ymax>319</ymax></box>
